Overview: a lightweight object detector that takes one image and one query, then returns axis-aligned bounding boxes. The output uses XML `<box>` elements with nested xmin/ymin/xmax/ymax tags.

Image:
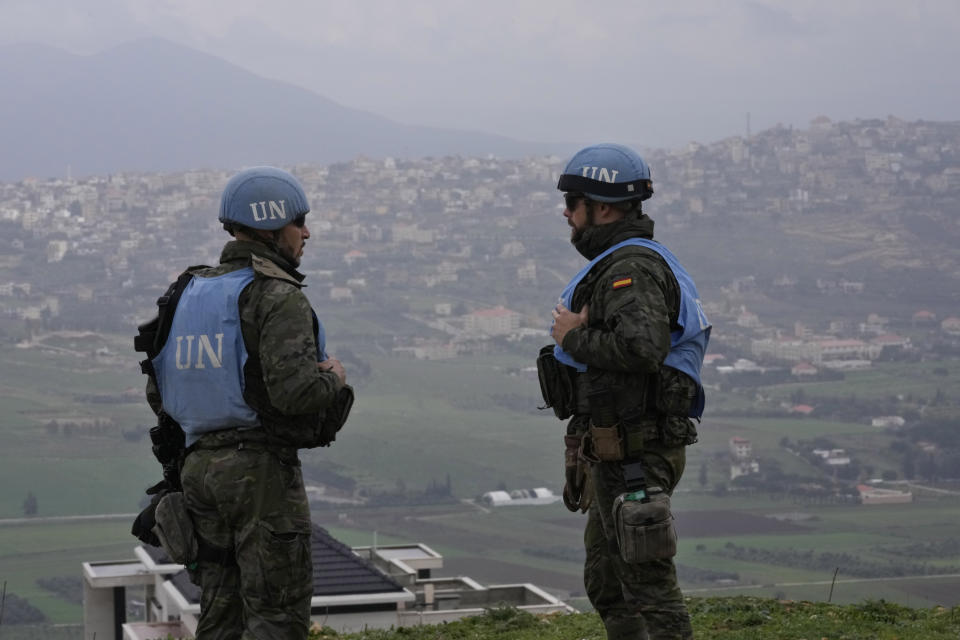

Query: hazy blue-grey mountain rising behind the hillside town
<box><xmin>0</xmin><ymin>39</ymin><xmax>559</xmax><ymax>181</ymax></box>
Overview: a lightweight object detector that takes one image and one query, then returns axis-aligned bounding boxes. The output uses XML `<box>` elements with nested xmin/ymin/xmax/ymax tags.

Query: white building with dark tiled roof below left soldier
<box><xmin>83</xmin><ymin>525</ymin><xmax>575</xmax><ymax>640</ymax></box>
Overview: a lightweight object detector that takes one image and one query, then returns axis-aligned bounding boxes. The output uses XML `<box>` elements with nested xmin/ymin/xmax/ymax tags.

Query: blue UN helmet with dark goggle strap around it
<box><xmin>557</xmin><ymin>143</ymin><xmax>653</xmax><ymax>202</ymax></box>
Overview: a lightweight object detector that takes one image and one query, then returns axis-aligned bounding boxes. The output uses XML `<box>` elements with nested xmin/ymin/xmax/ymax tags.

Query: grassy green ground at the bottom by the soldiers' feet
<box><xmin>310</xmin><ymin>597</ymin><xmax>960</xmax><ymax>640</ymax></box>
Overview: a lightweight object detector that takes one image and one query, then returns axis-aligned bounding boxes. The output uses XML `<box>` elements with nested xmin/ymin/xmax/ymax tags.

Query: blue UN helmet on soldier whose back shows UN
<box><xmin>220</xmin><ymin>167</ymin><xmax>310</xmax><ymax>231</ymax></box>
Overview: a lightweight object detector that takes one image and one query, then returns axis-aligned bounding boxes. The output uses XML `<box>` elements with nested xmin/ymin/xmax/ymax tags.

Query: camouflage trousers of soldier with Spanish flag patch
<box><xmin>583</xmin><ymin>443</ymin><xmax>693</xmax><ymax>640</ymax></box>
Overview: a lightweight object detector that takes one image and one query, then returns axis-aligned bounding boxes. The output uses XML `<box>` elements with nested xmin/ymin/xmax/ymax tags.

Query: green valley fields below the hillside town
<box><xmin>0</xmin><ymin>336</ymin><xmax>960</xmax><ymax>623</ymax></box>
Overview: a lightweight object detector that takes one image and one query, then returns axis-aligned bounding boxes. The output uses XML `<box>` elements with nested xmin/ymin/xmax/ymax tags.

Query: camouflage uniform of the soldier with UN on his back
<box><xmin>147</xmin><ymin>241</ymin><xmax>340</xmax><ymax>640</ymax></box>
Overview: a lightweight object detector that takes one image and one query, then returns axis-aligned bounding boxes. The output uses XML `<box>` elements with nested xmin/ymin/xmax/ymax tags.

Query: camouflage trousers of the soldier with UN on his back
<box><xmin>181</xmin><ymin>434</ymin><xmax>313</xmax><ymax>640</ymax></box>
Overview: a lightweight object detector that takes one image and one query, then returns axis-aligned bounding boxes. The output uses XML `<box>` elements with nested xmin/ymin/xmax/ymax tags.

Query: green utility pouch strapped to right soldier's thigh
<box><xmin>613</xmin><ymin>487</ymin><xmax>677</xmax><ymax>564</ymax></box>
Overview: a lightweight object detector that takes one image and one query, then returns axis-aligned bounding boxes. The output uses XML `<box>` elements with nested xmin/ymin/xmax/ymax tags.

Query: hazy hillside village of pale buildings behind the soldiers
<box><xmin>0</xmin><ymin>118</ymin><xmax>960</xmax><ymax>364</ymax></box>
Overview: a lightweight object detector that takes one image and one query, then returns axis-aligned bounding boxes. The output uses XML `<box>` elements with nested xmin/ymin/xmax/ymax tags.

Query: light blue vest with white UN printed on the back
<box><xmin>152</xmin><ymin>267</ymin><xmax>260</xmax><ymax>447</ymax></box>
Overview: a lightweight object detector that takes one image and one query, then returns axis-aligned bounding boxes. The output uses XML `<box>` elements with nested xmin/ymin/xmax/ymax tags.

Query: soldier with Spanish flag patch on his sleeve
<box><xmin>538</xmin><ymin>144</ymin><xmax>710</xmax><ymax>640</ymax></box>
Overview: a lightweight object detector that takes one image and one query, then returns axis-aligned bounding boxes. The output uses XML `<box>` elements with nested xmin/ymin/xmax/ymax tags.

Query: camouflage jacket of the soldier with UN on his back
<box><xmin>147</xmin><ymin>240</ymin><xmax>341</xmax><ymax>446</ymax></box>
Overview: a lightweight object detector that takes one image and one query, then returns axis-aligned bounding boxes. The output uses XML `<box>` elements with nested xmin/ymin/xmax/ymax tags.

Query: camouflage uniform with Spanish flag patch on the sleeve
<box><xmin>562</xmin><ymin>215</ymin><xmax>697</xmax><ymax>640</ymax></box>
